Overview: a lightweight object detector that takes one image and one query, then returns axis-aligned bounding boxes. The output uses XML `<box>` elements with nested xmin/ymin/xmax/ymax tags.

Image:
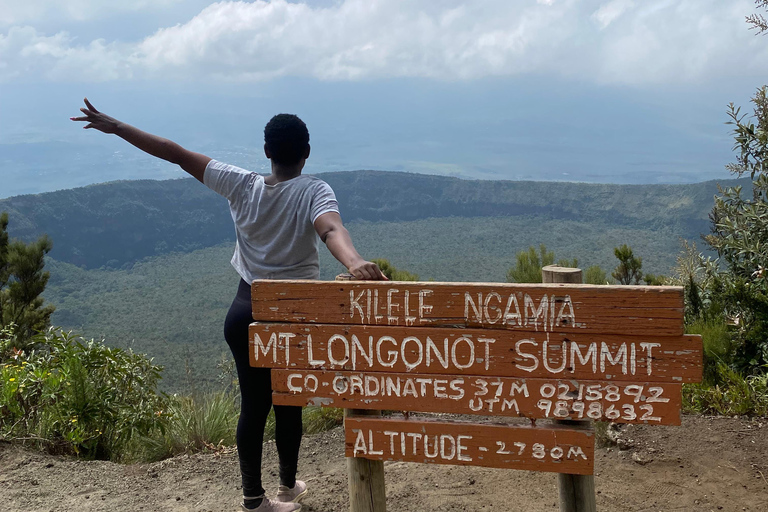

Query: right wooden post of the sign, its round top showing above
<box><xmin>541</xmin><ymin>265</ymin><xmax>597</xmax><ymax>512</ymax></box>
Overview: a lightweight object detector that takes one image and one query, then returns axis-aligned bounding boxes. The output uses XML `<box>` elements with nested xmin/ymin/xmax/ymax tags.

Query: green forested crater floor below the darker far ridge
<box><xmin>45</xmin><ymin>217</ymin><xmax>679</xmax><ymax>391</ymax></box>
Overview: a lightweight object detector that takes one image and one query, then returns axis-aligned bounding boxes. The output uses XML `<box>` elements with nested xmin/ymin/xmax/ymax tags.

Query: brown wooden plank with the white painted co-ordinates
<box><xmin>272</xmin><ymin>370</ymin><xmax>682</xmax><ymax>425</ymax></box>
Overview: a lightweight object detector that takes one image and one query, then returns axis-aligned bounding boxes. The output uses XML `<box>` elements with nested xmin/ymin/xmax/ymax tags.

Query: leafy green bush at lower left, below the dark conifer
<box><xmin>0</xmin><ymin>329</ymin><xmax>165</xmax><ymax>460</ymax></box>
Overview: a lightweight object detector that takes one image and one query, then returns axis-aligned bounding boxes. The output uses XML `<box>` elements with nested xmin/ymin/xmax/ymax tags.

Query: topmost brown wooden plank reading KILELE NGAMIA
<box><xmin>252</xmin><ymin>280</ymin><xmax>683</xmax><ymax>336</ymax></box>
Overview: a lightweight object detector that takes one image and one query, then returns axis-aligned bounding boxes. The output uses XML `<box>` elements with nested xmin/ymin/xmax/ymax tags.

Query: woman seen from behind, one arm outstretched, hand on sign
<box><xmin>71</xmin><ymin>99</ymin><xmax>386</xmax><ymax>512</ymax></box>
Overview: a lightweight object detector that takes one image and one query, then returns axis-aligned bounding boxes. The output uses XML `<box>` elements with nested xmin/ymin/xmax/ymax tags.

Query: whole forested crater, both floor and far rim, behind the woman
<box><xmin>0</xmin><ymin>171</ymin><xmax>748</xmax><ymax>390</ymax></box>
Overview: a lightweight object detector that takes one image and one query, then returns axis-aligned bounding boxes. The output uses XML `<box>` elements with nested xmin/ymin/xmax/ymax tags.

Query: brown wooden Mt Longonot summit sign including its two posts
<box><xmin>250</xmin><ymin>274</ymin><xmax>702</xmax><ymax>512</ymax></box>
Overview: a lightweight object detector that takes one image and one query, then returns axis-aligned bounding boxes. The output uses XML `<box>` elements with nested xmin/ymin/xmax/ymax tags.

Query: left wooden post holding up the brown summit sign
<box><xmin>336</xmin><ymin>274</ymin><xmax>387</xmax><ymax>512</ymax></box>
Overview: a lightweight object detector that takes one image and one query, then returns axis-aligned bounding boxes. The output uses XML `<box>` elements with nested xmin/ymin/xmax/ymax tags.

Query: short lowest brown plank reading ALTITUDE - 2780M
<box><xmin>344</xmin><ymin>417</ymin><xmax>595</xmax><ymax>475</ymax></box>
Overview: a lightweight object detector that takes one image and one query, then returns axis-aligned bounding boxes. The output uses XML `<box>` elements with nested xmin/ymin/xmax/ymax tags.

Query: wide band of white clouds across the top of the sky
<box><xmin>0</xmin><ymin>0</ymin><xmax>768</xmax><ymax>84</ymax></box>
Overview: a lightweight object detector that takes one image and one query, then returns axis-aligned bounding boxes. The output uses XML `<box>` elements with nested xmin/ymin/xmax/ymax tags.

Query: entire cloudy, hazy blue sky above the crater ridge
<box><xmin>0</xmin><ymin>0</ymin><xmax>768</xmax><ymax>197</ymax></box>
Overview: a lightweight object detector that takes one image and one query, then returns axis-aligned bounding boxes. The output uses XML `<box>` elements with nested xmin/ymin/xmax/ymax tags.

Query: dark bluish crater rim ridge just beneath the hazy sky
<box><xmin>0</xmin><ymin>170</ymin><xmax>749</xmax><ymax>268</ymax></box>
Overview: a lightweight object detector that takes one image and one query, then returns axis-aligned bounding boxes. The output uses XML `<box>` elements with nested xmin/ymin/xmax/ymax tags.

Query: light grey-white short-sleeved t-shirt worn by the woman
<box><xmin>203</xmin><ymin>160</ymin><xmax>339</xmax><ymax>283</ymax></box>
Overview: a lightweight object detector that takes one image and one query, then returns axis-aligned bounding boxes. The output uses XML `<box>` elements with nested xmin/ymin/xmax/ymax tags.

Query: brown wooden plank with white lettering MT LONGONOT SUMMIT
<box><xmin>250</xmin><ymin>323</ymin><xmax>702</xmax><ymax>382</ymax></box>
